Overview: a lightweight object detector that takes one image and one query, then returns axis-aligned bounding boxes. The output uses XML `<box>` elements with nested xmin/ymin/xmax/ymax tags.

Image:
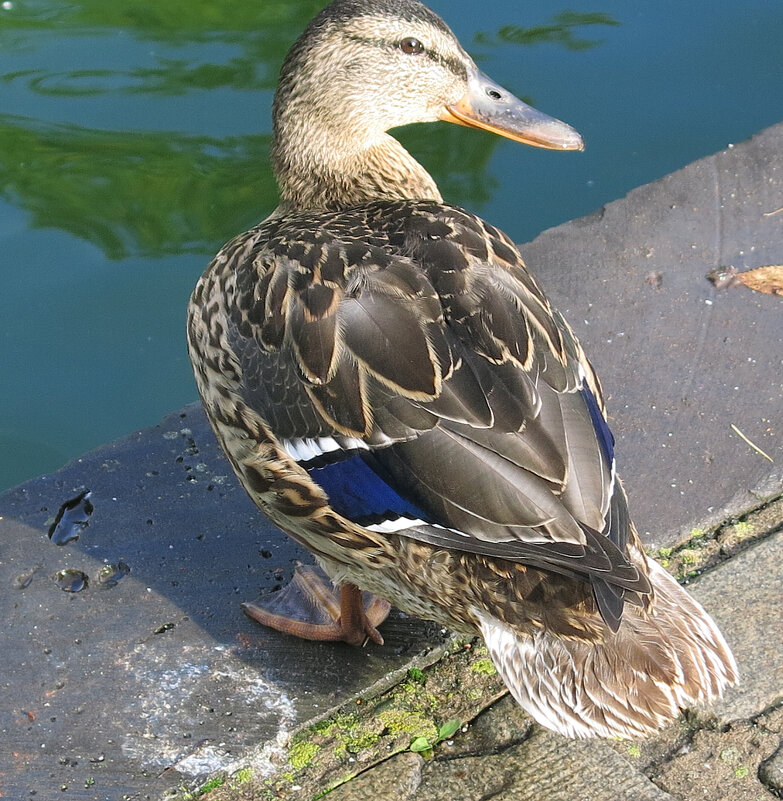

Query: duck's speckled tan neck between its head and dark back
<box><xmin>272</xmin><ymin>126</ymin><xmax>442</xmax><ymax>213</ymax></box>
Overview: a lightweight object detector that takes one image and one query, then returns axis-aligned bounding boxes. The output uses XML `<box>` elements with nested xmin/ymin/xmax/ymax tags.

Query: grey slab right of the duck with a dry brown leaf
<box><xmin>523</xmin><ymin>125</ymin><xmax>783</xmax><ymax>547</ymax></box>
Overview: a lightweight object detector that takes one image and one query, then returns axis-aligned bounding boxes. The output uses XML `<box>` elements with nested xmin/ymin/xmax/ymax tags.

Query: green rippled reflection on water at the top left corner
<box><xmin>0</xmin><ymin>0</ymin><xmax>323</xmax><ymax>95</ymax></box>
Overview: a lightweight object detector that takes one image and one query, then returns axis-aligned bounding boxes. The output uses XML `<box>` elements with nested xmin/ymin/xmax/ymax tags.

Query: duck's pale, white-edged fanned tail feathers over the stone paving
<box><xmin>474</xmin><ymin>560</ymin><xmax>737</xmax><ymax>738</ymax></box>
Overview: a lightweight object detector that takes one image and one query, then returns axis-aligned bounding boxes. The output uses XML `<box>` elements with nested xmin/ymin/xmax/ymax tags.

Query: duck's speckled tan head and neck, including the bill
<box><xmin>273</xmin><ymin>0</ymin><xmax>583</xmax><ymax>205</ymax></box>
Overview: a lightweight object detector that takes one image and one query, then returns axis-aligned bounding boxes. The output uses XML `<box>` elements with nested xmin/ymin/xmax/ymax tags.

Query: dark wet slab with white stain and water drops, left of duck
<box><xmin>0</xmin><ymin>406</ymin><xmax>443</xmax><ymax>799</ymax></box>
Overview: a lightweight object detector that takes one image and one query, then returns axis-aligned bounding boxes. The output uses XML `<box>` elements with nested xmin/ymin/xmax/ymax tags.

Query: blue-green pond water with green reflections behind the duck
<box><xmin>0</xmin><ymin>0</ymin><xmax>783</xmax><ymax>488</ymax></box>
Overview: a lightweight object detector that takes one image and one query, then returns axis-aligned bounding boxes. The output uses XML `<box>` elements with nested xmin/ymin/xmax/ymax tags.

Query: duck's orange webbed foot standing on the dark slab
<box><xmin>242</xmin><ymin>565</ymin><xmax>391</xmax><ymax>645</ymax></box>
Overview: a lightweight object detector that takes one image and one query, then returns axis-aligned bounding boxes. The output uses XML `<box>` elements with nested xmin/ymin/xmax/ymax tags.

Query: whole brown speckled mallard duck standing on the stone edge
<box><xmin>188</xmin><ymin>0</ymin><xmax>737</xmax><ymax>737</ymax></box>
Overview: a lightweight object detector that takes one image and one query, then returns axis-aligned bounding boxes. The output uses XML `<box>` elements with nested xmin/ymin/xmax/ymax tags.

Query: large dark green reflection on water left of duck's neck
<box><xmin>0</xmin><ymin>115</ymin><xmax>276</xmax><ymax>259</ymax></box>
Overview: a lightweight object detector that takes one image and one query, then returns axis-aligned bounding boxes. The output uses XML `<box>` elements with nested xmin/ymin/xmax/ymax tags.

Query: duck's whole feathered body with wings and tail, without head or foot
<box><xmin>188</xmin><ymin>195</ymin><xmax>736</xmax><ymax>737</ymax></box>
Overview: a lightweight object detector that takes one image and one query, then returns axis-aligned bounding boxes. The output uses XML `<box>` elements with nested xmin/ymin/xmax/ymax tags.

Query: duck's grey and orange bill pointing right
<box><xmin>440</xmin><ymin>69</ymin><xmax>584</xmax><ymax>150</ymax></box>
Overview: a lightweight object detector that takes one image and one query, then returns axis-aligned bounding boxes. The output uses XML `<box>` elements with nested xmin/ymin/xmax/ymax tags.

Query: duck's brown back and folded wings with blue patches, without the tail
<box><xmin>189</xmin><ymin>195</ymin><xmax>649</xmax><ymax>628</ymax></box>
